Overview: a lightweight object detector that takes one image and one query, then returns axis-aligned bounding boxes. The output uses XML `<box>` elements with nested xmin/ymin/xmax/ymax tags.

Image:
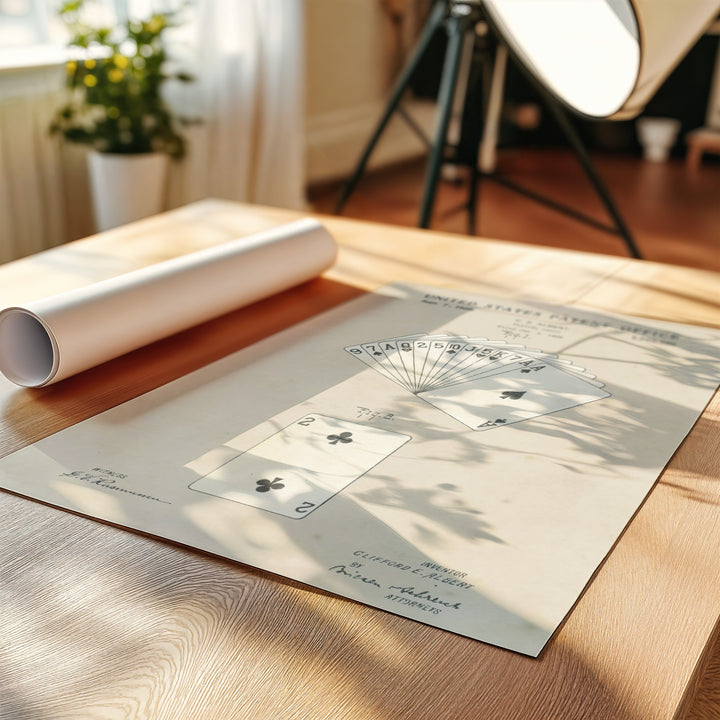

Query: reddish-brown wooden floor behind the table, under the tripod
<box><xmin>310</xmin><ymin>148</ymin><xmax>720</xmax><ymax>271</ymax></box>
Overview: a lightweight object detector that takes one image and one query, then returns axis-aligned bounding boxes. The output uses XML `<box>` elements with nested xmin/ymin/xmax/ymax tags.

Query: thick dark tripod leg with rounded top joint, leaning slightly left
<box><xmin>418</xmin><ymin>10</ymin><xmax>474</xmax><ymax>228</ymax></box>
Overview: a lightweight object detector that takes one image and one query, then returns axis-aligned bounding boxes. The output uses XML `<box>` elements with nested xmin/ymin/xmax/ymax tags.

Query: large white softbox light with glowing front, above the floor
<box><xmin>483</xmin><ymin>0</ymin><xmax>720</xmax><ymax>120</ymax></box>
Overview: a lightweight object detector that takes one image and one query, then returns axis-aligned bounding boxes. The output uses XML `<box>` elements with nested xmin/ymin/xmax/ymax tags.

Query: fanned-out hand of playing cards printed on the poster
<box><xmin>345</xmin><ymin>334</ymin><xmax>610</xmax><ymax>430</ymax></box>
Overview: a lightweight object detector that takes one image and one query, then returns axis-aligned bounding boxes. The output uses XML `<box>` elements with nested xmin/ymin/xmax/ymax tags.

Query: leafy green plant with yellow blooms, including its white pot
<box><xmin>50</xmin><ymin>0</ymin><xmax>192</xmax><ymax>230</ymax></box>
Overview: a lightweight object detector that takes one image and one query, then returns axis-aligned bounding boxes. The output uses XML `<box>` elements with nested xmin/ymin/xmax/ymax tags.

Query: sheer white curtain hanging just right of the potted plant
<box><xmin>170</xmin><ymin>0</ymin><xmax>305</xmax><ymax>208</ymax></box>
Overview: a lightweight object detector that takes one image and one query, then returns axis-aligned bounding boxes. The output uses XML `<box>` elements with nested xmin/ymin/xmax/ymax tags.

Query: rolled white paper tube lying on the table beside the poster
<box><xmin>0</xmin><ymin>218</ymin><xmax>337</xmax><ymax>387</ymax></box>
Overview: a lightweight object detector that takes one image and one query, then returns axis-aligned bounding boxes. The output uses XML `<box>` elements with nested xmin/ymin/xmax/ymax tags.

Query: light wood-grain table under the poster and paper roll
<box><xmin>0</xmin><ymin>201</ymin><xmax>720</xmax><ymax>720</ymax></box>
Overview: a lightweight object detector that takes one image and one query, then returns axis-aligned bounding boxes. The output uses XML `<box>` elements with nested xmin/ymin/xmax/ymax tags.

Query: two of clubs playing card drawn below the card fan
<box><xmin>190</xmin><ymin>413</ymin><xmax>410</xmax><ymax>519</ymax></box>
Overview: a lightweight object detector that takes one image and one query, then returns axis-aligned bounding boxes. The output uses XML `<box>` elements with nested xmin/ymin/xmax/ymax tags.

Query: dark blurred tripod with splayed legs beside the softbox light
<box><xmin>335</xmin><ymin>0</ymin><xmax>642</xmax><ymax>258</ymax></box>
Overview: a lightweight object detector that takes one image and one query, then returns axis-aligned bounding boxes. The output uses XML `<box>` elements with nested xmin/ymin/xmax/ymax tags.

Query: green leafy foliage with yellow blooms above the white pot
<box><xmin>50</xmin><ymin>0</ymin><xmax>192</xmax><ymax>158</ymax></box>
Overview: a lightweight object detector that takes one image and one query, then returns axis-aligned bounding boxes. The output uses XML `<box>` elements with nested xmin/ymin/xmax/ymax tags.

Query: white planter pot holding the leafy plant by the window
<box><xmin>88</xmin><ymin>150</ymin><xmax>168</xmax><ymax>231</ymax></box>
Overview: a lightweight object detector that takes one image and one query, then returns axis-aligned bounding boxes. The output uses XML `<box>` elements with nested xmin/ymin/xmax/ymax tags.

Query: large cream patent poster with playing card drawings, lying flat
<box><xmin>0</xmin><ymin>286</ymin><xmax>720</xmax><ymax>656</ymax></box>
